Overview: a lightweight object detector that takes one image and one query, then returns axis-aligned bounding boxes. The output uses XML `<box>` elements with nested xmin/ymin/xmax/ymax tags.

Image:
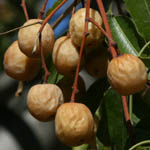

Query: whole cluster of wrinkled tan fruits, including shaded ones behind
<box><xmin>4</xmin><ymin>4</ymin><xmax>147</xmax><ymax>146</ymax></box>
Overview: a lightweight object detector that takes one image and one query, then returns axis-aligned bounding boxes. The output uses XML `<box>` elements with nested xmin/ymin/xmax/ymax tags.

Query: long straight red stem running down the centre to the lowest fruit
<box><xmin>71</xmin><ymin>0</ymin><xmax>90</xmax><ymax>102</ymax></box>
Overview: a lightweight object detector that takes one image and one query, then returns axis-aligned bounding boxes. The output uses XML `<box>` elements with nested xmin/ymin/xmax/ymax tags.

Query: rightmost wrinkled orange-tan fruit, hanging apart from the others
<box><xmin>107</xmin><ymin>54</ymin><xmax>147</xmax><ymax>96</ymax></box>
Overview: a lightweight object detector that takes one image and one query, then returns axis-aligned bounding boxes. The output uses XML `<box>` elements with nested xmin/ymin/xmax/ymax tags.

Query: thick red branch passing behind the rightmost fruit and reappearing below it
<box><xmin>97</xmin><ymin>0</ymin><xmax>134</xmax><ymax>144</ymax></box>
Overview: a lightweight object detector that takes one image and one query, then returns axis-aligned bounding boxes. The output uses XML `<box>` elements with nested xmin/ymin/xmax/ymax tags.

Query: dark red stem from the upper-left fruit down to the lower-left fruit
<box><xmin>39</xmin><ymin>34</ymin><xmax>50</xmax><ymax>83</ymax></box>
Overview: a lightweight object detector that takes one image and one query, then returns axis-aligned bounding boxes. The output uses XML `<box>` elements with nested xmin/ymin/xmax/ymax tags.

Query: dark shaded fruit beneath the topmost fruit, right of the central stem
<box><xmin>85</xmin><ymin>46</ymin><xmax>109</xmax><ymax>78</ymax></box>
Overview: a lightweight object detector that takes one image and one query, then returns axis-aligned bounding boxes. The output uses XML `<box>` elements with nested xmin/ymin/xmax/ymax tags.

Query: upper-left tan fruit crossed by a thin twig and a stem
<box><xmin>18</xmin><ymin>19</ymin><xmax>54</xmax><ymax>57</ymax></box>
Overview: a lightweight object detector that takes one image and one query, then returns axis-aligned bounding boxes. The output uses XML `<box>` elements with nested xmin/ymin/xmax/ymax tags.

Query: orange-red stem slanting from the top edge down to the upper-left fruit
<box><xmin>39</xmin><ymin>0</ymin><xmax>67</xmax><ymax>33</ymax></box>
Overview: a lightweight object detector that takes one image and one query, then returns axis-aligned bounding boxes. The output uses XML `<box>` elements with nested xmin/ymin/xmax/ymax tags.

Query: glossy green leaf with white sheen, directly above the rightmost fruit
<box><xmin>109</xmin><ymin>16</ymin><xmax>140</xmax><ymax>55</ymax></box>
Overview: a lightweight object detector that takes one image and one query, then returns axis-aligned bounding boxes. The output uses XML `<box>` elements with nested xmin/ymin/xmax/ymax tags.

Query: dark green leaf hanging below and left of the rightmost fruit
<box><xmin>98</xmin><ymin>89</ymin><xmax>128</xmax><ymax>150</ymax></box>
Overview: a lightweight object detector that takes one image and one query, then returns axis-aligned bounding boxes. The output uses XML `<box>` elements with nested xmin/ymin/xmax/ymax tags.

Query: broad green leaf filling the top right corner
<box><xmin>125</xmin><ymin>0</ymin><xmax>150</xmax><ymax>41</ymax></box>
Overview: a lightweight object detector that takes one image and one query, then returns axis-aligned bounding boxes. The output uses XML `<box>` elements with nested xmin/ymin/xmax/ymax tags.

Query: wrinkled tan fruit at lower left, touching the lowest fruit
<box><xmin>27</xmin><ymin>84</ymin><xmax>64</xmax><ymax>122</ymax></box>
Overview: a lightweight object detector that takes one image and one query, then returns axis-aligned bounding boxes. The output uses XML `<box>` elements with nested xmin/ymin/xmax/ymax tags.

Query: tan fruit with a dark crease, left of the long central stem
<box><xmin>52</xmin><ymin>36</ymin><xmax>79</xmax><ymax>76</ymax></box>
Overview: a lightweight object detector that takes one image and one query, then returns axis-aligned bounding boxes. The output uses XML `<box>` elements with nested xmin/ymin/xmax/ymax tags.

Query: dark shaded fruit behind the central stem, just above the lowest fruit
<box><xmin>57</xmin><ymin>76</ymin><xmax>86</xmax><ymax>102</ymax></box>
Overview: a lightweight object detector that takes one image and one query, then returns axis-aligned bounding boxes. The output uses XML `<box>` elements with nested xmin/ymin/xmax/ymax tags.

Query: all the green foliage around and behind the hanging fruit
<box><xmin>0</xmin><ymin>0</ymin><xmax>150</xmax><ymax>150</ymax></box>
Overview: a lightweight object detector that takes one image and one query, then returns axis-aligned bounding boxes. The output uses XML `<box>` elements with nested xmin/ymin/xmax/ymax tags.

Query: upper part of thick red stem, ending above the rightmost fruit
<box><xmin>97</xmin><ymin>0</ymin><xmax>117</xmax><ymax>57</ymax></box>
